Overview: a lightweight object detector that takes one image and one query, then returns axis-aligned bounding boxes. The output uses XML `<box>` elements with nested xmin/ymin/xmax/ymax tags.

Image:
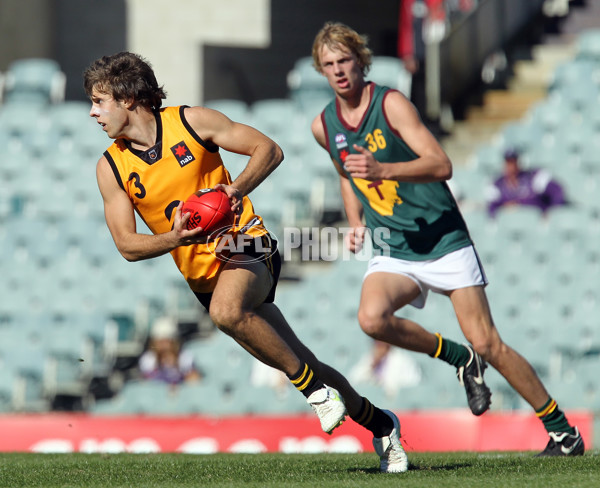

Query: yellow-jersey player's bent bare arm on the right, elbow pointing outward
<box><xmin>185</xmin><ymin>107</ymin><xmax>283</xmax><ymax>210</ymax></box>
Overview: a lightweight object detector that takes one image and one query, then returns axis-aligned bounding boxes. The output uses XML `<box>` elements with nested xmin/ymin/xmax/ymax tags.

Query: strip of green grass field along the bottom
<box><xmin>0</xmin><ymin>451</ymin><xmax>600</xmax><ymax>488</ymax></box>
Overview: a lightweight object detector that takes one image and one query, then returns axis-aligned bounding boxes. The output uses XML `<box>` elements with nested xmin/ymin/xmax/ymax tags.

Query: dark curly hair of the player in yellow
<box><xmin>83</xmin><ymin>52</ymin><xmax>167</xmax><ymax>109</ymax></box>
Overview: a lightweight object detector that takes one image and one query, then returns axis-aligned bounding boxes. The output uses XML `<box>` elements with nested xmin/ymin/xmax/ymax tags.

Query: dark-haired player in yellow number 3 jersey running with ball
<box><xmin>84</xmin><ymin>52</ymin><xmax>408</xmax><ymax>472</ymax></box>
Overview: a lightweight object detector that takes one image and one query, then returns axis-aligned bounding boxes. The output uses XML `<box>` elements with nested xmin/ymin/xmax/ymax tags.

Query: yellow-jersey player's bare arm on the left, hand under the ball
<box><xmin>96</xmin><ymin>156</ymin><xmax>203</xmax><ymax>261</ymax></box>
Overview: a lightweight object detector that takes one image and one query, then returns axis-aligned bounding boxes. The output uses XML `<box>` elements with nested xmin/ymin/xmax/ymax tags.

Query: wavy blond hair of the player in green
<box><xmin>312</xmin><ymin>22</ymin><xmax>373</xmax><ymax>75</ymax></box>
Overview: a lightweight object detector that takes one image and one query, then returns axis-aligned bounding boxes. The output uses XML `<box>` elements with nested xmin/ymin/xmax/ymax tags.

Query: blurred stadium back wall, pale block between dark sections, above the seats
<box><xmin>0</xmin><ymin>0</ymin><xmax>398</xmax><ymax>104</ymax></box>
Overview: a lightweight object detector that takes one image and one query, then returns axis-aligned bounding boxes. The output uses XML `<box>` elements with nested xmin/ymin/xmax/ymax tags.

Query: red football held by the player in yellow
<box><xmin>181</xmin><ymin>188</ymin><xmax>235</xmax><ymax>234</ymax></box>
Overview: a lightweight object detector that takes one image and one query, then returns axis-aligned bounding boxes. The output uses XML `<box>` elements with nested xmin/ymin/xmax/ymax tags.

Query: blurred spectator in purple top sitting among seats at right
<box><xmin>486</xmin><ymin>149</ymin><xmax>567</xmax><ymax>217</ymax></box>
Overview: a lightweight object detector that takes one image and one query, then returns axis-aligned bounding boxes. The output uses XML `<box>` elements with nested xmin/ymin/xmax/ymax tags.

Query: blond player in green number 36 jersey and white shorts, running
<box><xmin>312</xmin><ymin>22</ymin><xmax>584</xmax><ymax>456</ymax></box>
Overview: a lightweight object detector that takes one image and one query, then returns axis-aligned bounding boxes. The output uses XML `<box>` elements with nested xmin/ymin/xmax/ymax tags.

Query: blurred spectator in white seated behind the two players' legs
<box><xmin>348</xmin><ymin>340</ymin><xmax>421</xmax><ymax>398</ymax></box>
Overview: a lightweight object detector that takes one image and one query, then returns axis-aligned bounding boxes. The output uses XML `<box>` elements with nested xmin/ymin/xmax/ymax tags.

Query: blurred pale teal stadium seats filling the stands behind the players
<box><xmin>0</xmin><ymin>31</ymin><xmax>600</xmax><ymax>415</ymax></box>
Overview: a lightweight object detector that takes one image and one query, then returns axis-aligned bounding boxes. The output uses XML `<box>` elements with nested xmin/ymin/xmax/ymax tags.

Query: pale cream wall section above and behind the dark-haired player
<box><xmin>127</xmin><ymin>0</ymin><xmax>271</xmax><ymax>105</ymax></box>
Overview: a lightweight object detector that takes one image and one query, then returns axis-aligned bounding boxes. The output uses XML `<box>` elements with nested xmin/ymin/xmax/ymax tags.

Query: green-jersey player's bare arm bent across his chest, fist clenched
<box><xmin>344</xmin><ymin>92</ymin><xmax>452</xmax><ymax>183</ymax></box>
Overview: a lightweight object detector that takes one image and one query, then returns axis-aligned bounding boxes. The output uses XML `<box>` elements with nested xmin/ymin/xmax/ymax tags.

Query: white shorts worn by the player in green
<box><xmin>363</xmin><ymin>246</ymin><xmax>488</xmax><ymax>308</ymax></box>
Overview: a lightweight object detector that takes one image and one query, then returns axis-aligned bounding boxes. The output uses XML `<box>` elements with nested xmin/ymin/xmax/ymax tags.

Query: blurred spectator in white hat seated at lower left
<box><xmin>139</xmin><ymin>317</ymin><xmax>202</xmax><ymax>385</ymax></box>
